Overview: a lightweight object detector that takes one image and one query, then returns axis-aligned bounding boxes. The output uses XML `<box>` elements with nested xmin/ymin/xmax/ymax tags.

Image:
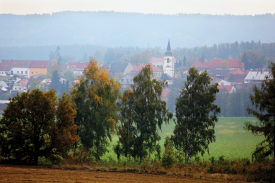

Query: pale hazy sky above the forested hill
<box><xmin>0</xmin><ymin>0</ymin><xmax>275</xmax><ymax>15</ymax></box>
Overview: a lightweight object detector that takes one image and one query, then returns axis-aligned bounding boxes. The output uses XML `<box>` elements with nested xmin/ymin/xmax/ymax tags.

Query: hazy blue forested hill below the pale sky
<box><xmin>0</xmin><ymin>12</ymin><xmax>275</xmax><ymax>48</ymax></box>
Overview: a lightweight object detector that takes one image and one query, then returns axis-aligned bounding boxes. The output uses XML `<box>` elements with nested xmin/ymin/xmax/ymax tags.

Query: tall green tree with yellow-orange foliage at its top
<box><xmin>71</xmin><ymin>59</ymin><xmax>120</xmax><ymax>160</ymax></box>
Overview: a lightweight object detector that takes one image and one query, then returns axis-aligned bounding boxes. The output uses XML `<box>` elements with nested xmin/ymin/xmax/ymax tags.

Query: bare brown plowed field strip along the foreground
<box><xmin>0</xmin><ymin>165</ymin><xmax>229</xmax><ymax>183</ymax></box>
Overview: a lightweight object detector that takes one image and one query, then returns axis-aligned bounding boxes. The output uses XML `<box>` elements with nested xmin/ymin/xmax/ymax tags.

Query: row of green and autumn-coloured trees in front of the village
<box><xmin>0</xmin><ymin>59</ymin><xmax>275</xmax><ymax>166</ymax></box>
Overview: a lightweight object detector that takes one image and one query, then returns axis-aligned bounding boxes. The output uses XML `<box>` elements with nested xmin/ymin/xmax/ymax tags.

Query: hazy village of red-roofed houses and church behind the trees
<box><xmin>0</xmin><ymin>41</ymin><xmax>270</xmax><ymax>112</ymax></box>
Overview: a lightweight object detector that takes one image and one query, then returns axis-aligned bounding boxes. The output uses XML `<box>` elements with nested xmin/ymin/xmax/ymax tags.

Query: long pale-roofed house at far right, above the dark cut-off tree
<box><xmin>244</xmin><ymin>71</ymin><xmax>272</xmax><ymax>83</ymax></box>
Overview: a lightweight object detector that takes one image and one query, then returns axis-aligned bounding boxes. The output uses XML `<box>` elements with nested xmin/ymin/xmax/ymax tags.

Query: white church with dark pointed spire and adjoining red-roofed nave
<box><xmin>150</xmin><ymin>40</ymin><xmax>176</xmax><ymax>78</ymax></box>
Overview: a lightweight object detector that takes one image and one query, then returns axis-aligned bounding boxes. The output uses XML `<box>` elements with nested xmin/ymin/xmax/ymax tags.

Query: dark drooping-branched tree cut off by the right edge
<box><xmin>245</xmin><ymin>63</ymin><xmax>275</xmax><ymax>160</ymax></box>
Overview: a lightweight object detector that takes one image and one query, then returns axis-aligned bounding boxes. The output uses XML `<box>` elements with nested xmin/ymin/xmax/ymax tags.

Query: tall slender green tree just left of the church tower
<box><xmin>131</xmin><ymin>65</ymin><xmax>172</xmax><ymax>161</ymax></box>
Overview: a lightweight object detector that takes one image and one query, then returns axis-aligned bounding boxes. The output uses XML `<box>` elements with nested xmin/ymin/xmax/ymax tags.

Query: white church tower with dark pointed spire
<box><xmin>163</xmin><ymin>40</ymin><xmax>174</xmax><ymax>78</ymax></box>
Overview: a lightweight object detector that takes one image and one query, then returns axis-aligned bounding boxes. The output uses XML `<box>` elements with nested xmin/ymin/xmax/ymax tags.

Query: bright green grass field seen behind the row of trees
<box><xmin>102</xmin><ymin>117</ymin><xmax>264</xmax><ymax>160</ymax></box>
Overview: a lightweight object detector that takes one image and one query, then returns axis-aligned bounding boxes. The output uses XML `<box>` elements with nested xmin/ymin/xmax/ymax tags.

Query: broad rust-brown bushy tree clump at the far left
<box><xmin>0</xmin><ymin>89</ymin><xmax>78</xmax><ymax>165</ymax></box>
